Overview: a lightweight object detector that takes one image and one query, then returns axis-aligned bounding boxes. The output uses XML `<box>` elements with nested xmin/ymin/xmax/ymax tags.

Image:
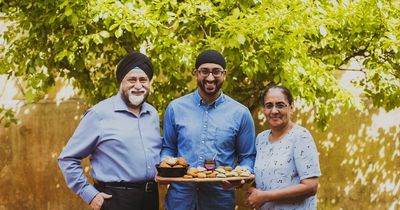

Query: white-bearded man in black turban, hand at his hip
<box><xmin>58</xmin><ymin>52</ymin><xmax>162</xmax><ymax>210</ymax></box>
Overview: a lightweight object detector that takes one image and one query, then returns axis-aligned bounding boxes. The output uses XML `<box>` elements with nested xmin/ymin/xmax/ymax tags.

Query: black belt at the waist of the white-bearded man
<box><xmin>95</xmin><ymin>181</ymin><xmax>157</xmax><ymax>192</ymax></box>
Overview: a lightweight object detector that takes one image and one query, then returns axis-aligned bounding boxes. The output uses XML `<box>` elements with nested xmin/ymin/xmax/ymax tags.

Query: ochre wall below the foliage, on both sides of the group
<box><xmin>0</xmin><ymin>80</ymin><xmax>400</xmax><ymax>210</ymax></box>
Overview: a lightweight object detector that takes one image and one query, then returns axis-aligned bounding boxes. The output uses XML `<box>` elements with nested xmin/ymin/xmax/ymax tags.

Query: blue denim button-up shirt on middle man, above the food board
<box><xmin>161</xmin><ymin>90</ymin><xmax>256</xmax><ymax>170</ymax></box>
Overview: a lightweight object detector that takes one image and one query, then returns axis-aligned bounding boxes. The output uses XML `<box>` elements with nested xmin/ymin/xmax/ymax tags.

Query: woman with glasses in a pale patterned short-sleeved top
<box><xmin>247</xmin><ymin>85</ymin><xmax>321</xmax><ymax>210</ymax></box>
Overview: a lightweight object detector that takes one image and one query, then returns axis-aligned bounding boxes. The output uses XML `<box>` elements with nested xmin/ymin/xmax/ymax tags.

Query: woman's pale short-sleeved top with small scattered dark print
<box><xmin>254</xmin><ymin>125</ymin><xmax>321</xmax><ymax>210</ymax></box>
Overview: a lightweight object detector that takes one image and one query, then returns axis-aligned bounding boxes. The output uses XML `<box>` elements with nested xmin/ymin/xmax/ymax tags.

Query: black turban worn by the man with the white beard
<box><xmin>116</xmin><ymin>52</ymin><xmax>153</xmax><ymax>84</ymax></box>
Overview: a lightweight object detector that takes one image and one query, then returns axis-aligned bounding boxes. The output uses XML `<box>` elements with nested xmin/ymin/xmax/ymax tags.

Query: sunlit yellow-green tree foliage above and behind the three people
<box><xmin>0</xmin><ymin>0</ymin><xmax>400</xmax><ymax>129</ymax></box>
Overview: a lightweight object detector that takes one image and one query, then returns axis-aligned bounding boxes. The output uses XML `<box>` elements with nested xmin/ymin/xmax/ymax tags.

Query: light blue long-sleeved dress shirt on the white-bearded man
<box><xmin>58</xmin><ymin>93</ymin><xmax>162</xmax><ymax>203</ymax></box>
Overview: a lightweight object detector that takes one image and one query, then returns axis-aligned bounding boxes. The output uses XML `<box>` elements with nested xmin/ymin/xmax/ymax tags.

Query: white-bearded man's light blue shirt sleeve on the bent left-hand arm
<box><xmin>58</xmin><ymin>110</ymin><xmax>101</xmax><ymax>204</ymax></box>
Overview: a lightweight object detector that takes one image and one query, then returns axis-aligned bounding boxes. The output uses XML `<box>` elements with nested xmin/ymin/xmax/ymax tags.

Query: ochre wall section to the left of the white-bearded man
<box><xmin>0</xmin><ymin>100</ymin><xmax>85</xmax><ymax>210</ymax></box>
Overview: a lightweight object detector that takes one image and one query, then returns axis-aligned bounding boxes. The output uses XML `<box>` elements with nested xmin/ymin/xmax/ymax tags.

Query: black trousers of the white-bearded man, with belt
<box><xmin>94</xmin><ymin>183</ymin><xmax>159</xmax><ymax>210</ymax></box>
